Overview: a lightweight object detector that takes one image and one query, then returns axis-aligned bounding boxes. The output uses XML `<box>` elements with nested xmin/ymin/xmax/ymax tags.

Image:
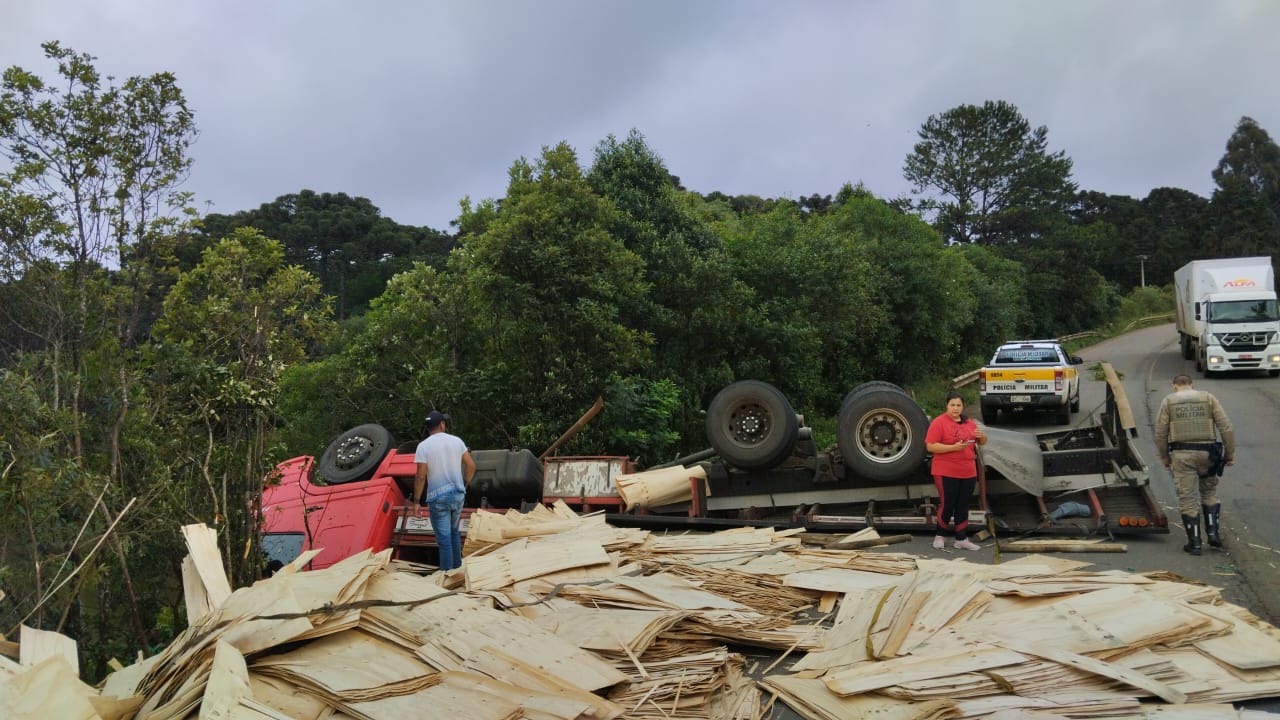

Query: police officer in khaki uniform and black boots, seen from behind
<box><xmin>1156</xmin><ymin>374</ymin><xmax>1235</xmax><ymax>555</ymax></box>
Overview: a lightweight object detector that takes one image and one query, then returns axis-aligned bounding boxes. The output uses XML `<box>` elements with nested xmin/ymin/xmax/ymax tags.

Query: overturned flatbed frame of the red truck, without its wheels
<box><xmin>578</xmin><ymin>365</ymin><xmax>1169</xmax><ymax>536</ymax></box>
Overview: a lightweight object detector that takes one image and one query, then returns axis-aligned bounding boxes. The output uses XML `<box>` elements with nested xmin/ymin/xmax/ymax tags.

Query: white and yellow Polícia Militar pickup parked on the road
<box><xmin>978</xmin><ymin>340</ymin><xmax>1084</xmax><ymax>425</ymax></box>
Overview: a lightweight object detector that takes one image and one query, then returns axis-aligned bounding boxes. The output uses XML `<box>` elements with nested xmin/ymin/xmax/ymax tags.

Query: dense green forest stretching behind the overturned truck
<box><xmin>0</xmin><ymin>44</ymin><xmax>1280</xmax><ymax>676</ymax></box>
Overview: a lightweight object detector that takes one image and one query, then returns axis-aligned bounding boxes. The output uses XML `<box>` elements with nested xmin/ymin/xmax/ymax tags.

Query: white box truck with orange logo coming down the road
<box><xmin>1174</xmin><ymin>258</ymin><xmax>1280</xmax><ymax>377</ymax></box>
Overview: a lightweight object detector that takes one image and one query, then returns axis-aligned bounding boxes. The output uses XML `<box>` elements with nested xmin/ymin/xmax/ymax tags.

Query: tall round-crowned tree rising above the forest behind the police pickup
<box><xmin>902</xmin><ymin>100</ymin><xmax>1075</xmax><ymax>245</ymax></box>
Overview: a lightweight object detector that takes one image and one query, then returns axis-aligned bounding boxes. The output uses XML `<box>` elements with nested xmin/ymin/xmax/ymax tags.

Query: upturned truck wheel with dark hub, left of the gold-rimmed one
<box><xmin>707</xmin><ymin>380</ymin><xmax>800</xmax><ymax>470</ymax></box>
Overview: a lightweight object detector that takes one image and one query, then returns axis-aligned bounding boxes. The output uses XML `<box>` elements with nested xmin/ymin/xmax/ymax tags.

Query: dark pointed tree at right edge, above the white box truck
<box><xmin>1211</xmin><ymin>117</ymin><xmax>1280</xmax><ymax>256</ymax></box>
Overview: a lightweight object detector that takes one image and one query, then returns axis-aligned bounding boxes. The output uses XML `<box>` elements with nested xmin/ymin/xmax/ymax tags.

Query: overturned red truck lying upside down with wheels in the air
<box><xmin>262</xmin><ymin>365</ymin><xmax>1169</xmax><ymax>568</ymax></box>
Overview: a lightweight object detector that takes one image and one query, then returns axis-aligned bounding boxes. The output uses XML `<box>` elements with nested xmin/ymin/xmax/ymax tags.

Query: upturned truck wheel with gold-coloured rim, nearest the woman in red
<box><xmin>836</xmin><ymin>387</ymin><xmax>929</xmax><ymax>483</ymax></box>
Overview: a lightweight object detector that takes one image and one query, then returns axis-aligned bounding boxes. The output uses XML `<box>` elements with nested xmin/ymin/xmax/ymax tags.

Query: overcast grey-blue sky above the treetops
<box><xmin>0</xmin><ymin>0</ymin><xmax>1280</xmax><ymax>229</ymax></box>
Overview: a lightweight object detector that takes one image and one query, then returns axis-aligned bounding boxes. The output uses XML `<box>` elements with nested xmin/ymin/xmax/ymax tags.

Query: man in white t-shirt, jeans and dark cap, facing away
<box><xmin>408</xmin><ymin>410</ymin><xmax>476</xmax><ymax>570</ymax></box>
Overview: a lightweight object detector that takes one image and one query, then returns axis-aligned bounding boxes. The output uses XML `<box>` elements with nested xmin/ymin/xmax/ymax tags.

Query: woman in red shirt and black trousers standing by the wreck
<box><xmin>924</xmin><ymin>391</ymin><xmax>987</xmax><ymax>550</ymax></box>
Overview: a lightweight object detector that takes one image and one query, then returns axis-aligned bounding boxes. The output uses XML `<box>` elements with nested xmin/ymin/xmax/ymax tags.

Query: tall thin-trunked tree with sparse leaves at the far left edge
<box><xmin>0</xmin><ymin>42</ymin><xmax>196</xmax><ymax>674</ymax></box>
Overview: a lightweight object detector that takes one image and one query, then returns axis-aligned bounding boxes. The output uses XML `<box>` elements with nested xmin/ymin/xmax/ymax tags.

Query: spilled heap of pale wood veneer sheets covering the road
<box><xmin>0</xmin><ymin>505</ymin><xmax>1280</xmax><ymax>720</ymax></box>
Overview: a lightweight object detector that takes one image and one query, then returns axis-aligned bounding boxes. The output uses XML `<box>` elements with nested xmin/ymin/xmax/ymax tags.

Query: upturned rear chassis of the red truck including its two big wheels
<box><xmin>565</xmin><ymin>364</ymin><xmax>1169</xmax><ymax>536</ymax></box>
